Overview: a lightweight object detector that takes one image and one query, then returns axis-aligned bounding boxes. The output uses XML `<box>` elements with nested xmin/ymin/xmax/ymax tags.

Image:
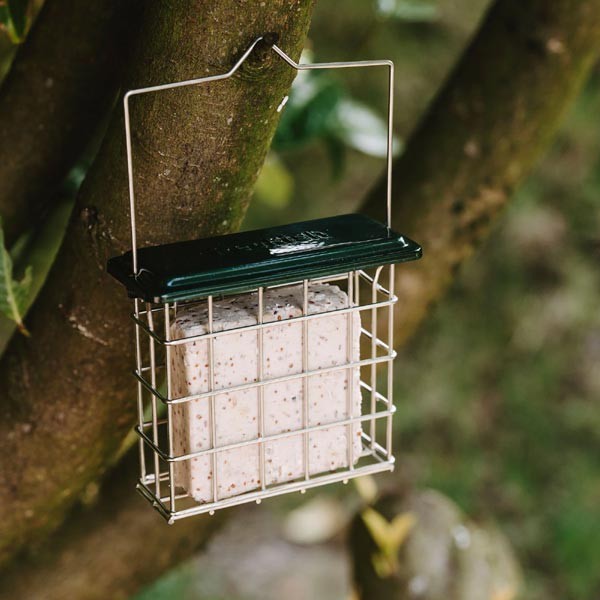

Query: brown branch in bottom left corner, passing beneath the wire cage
<box><xmin>0</xmin><ymin>452</ymin><xmax>223</xmax><ymax>600</ymax></box>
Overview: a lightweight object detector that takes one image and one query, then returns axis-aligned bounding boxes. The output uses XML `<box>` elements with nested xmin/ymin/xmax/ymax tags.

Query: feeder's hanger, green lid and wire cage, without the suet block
<box><xmin>108</xmin><ymin>37</ymin><xmax>421</xmax><ymax>523</ymax></box>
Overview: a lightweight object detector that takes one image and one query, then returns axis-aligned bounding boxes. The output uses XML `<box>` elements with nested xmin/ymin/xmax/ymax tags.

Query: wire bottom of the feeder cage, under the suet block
<box><xmin>136</xmin><ymin>435</ymin><xmax>395</xmax><ymax>525</ymax></box>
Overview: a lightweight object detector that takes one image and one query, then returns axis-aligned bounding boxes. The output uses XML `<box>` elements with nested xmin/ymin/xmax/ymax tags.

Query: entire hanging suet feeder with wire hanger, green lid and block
<box><xmin>108</xmin><ymin>38</ymin><xmax>421</xmax><ymax>523</ymax></box>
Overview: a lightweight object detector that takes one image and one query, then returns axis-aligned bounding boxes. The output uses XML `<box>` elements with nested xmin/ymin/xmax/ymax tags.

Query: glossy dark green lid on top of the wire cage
<box><xmin>108</xmin><ymin>214</ymin><xmax>422</xmax><ymax>303</ymax></box>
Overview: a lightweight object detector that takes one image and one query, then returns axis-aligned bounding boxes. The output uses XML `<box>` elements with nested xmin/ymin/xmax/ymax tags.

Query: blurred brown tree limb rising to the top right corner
<box><xmin>365</xmin><ymin>0</ymin><xmax>600</xmax><ymax>344</ymax></box>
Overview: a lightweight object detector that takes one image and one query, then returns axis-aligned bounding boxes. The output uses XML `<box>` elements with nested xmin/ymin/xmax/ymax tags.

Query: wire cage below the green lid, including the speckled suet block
<box><xmin>133</xmin><ymin>266</ymin><xmax>396</xmax><ymax>521</ymax></box>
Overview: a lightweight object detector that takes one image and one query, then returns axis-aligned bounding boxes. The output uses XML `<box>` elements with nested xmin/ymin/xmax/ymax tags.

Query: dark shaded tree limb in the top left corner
<box><xmin>0</xmin><ymin>0</ymin><xmax>134</xmax><ymax>245</ymax></box>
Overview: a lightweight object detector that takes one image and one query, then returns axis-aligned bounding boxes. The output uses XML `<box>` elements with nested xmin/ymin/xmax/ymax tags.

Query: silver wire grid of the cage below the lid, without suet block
<box><xmin>132</xmin><ymin>265</ymin><xmax>397</xmax><ymax>523</ymax></box>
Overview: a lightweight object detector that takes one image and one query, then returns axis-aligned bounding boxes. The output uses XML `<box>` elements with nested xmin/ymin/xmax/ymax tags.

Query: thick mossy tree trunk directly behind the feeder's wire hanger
<box><xmin>0</xmin><ymin>0</ymin><xmax>312</xmax><ymax>560</ymax></box>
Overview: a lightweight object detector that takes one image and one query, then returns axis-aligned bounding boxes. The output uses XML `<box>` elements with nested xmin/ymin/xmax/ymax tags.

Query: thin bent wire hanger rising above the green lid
<box><xmin>123</xmin><ymin>36</ymin><xmax>394</xmax><ymax>277</ymax></box>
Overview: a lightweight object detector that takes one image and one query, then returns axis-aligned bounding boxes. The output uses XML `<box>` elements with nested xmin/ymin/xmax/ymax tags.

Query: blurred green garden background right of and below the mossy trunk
<box><xmin>132</xmin><ymin>0</ymin><xmax>600</xmax><ymax>600</ymax></box>
